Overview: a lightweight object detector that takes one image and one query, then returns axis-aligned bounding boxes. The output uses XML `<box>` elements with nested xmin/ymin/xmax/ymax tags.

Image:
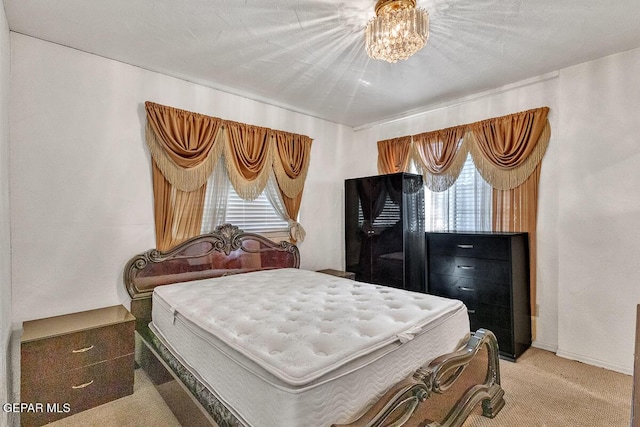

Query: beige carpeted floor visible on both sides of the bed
<box><xmin>42</xmin><ymin>348</ymin><xmax>632</xmax><ymax>427</ymax></box>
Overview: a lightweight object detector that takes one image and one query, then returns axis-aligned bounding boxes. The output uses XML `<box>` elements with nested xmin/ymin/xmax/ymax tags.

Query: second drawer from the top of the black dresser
<box><xmin>429</xmin><ymin>255</ymin><xmax>511</xmax><ymax>284</ymax></box>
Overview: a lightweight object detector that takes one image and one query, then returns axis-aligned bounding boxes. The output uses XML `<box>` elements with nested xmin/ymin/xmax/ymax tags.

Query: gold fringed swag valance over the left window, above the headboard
<box><xmin>145</xmin><ymin>101</ymin><xmax>313</xmax><ymax>200</ymax></box>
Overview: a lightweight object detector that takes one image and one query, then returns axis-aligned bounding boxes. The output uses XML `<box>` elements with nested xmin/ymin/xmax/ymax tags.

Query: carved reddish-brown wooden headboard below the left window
<box><xmin>123</xmin><ymin>224</ymin><xmax>300</xmax><ymax>331</ymax></box>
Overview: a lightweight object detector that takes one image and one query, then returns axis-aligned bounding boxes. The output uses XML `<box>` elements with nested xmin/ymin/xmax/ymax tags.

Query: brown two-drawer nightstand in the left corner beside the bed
<box><xmin>20</xmin><ymin>305</ymin><xmax>135</xmax><ymax>426</ymax></box>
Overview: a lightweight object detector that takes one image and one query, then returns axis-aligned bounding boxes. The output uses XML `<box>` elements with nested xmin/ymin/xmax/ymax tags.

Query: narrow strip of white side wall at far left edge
<box><xmin>0</xmin><ymin>1</ymin><xmax>12</xmax><ymax>426</ymax></box>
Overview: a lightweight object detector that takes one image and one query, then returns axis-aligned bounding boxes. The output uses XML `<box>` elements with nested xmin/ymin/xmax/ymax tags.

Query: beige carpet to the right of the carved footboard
<box><xmin>464</xmin><ymin>348</ymin><xmax>633</xmax><ymax>427</ymax></box>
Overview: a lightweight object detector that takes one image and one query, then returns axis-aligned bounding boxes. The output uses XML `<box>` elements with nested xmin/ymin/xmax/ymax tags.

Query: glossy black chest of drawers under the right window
<box><xmin>426</xmin><ymin>233</ymin><xmax>531</xmax><ymax>360</ymax></box>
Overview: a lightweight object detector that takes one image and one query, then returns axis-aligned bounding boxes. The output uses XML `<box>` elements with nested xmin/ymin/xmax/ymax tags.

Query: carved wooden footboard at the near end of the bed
<box><xmin>334</xmin><ymin>329</ymin><xmax>504</xmax><ymax>427</ymax></box>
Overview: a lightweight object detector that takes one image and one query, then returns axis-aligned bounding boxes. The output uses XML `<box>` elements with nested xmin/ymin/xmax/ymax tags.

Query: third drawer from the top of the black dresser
<box><xmin>429</xmin><ymin>273</ymin><xmax>511</xmax><ymax>307</ymax></box>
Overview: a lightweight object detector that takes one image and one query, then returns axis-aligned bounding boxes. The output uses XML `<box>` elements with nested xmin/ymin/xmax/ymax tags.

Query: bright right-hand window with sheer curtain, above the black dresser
<box><xmin>425</xmin><ymin>155</ymin><xmax>492</xmax><ymax>231</ymax></box>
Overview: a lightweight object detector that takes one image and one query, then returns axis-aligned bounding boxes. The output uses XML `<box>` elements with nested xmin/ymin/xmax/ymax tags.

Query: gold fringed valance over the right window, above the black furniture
<box><xmin>378</xmin><ymin>107</ymin><xmax>551</xmax><ymax>191</ymax></box>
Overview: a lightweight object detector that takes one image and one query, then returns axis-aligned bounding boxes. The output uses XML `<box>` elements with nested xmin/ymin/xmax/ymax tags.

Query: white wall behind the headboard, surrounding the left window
<box><xmin>10</xmin><ymin>33</ymin><xmax>353</xmax><ymax>322</ymax></box>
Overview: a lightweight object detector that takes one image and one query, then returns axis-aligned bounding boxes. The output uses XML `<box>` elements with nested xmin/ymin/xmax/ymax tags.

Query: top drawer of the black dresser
<box><xmin>427</xmin><ymin>233</ymin><xmax>510</xmax><ymax>260</ymax></box>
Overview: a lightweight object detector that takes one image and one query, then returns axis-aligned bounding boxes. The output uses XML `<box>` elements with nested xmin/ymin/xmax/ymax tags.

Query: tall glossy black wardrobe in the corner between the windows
<box><xmin>345</xmin><ymin>173</ymin><xmax>426</xmax><ymax>292</ymax></box>
